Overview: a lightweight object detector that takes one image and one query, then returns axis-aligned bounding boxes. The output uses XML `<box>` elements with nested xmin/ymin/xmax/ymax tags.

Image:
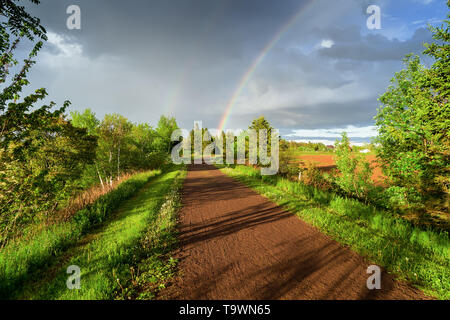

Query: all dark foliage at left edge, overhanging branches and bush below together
<box><xmin>0</xmin><ymin>0</ymin><xmax>96</xmax><ymax>243</ymax></box>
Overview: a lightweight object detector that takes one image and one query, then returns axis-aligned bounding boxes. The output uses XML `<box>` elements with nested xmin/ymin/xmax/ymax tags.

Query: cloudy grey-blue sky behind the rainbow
<box><xmin>23</xmin><ymin>0</ymin><xmax>448</xmax><ymax>141</ymax></box>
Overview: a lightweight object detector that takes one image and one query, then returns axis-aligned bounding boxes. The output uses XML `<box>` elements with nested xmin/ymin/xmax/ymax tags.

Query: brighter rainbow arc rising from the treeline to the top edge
<box><xmin>219</xmin><ymin>0</ymin><xmax>314</xmax><ymax>132</ymax></box>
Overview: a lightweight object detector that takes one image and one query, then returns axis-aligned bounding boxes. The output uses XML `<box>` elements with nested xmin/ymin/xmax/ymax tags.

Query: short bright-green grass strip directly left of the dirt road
<box><xmin>20</xmin><ymin>165</ymin><xmax>185</xmax><ymax>300</ymax></box>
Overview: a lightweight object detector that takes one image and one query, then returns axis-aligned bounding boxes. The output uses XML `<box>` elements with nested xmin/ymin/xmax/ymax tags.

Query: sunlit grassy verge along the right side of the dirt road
<box><xmin>221</xmin><ymin>166</ymin><xmax>450</xmax><ymax>299</ymax></box>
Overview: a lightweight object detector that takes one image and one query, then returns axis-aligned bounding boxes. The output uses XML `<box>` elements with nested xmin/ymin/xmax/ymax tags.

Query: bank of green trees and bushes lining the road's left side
<box><xmin>0</xmin><ymin>104</ymin><xmax>177</xmax><ymax>241</ymax></box>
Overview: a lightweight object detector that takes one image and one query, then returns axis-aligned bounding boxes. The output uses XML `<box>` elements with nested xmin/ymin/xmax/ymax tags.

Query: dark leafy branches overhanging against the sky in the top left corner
<box><xmin>0</xmin><ymin>0</ymin><xmax>63</xmax><ymax>156</ymax></box>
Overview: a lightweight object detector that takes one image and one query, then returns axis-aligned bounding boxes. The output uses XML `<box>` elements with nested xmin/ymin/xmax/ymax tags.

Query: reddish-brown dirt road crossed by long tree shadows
<box><xmin>160</xmin><ymin>165</ymin><xmax>426</xmax><ymax>299</ymax></box>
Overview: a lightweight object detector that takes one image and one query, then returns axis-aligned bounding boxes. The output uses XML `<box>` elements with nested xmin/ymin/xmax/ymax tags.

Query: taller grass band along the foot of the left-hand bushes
<box><xmin>0</xmin><ymin>171</ymin><xmax>159</xmax><ymax>299</ymax></box>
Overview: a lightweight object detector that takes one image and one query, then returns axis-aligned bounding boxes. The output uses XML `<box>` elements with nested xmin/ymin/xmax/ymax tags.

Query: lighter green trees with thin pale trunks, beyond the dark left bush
<box><xmin>71</xmin><ymin>109</ymin><xmax>178</xmax><ymax>190</ymax></box>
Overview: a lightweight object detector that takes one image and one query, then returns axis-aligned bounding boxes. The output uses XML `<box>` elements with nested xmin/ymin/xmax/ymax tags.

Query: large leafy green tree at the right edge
<box><xmin>375</xmin><ymin>3</ymin><xmax>450</xmax><ymax>194</ymax></box>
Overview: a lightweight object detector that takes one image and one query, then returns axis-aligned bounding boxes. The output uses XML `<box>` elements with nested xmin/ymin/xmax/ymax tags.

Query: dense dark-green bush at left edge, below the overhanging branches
<box><xmin>0</xmin><ymin>119</ymin><xmax>96</xmax><ymax>240</ymax></box>
